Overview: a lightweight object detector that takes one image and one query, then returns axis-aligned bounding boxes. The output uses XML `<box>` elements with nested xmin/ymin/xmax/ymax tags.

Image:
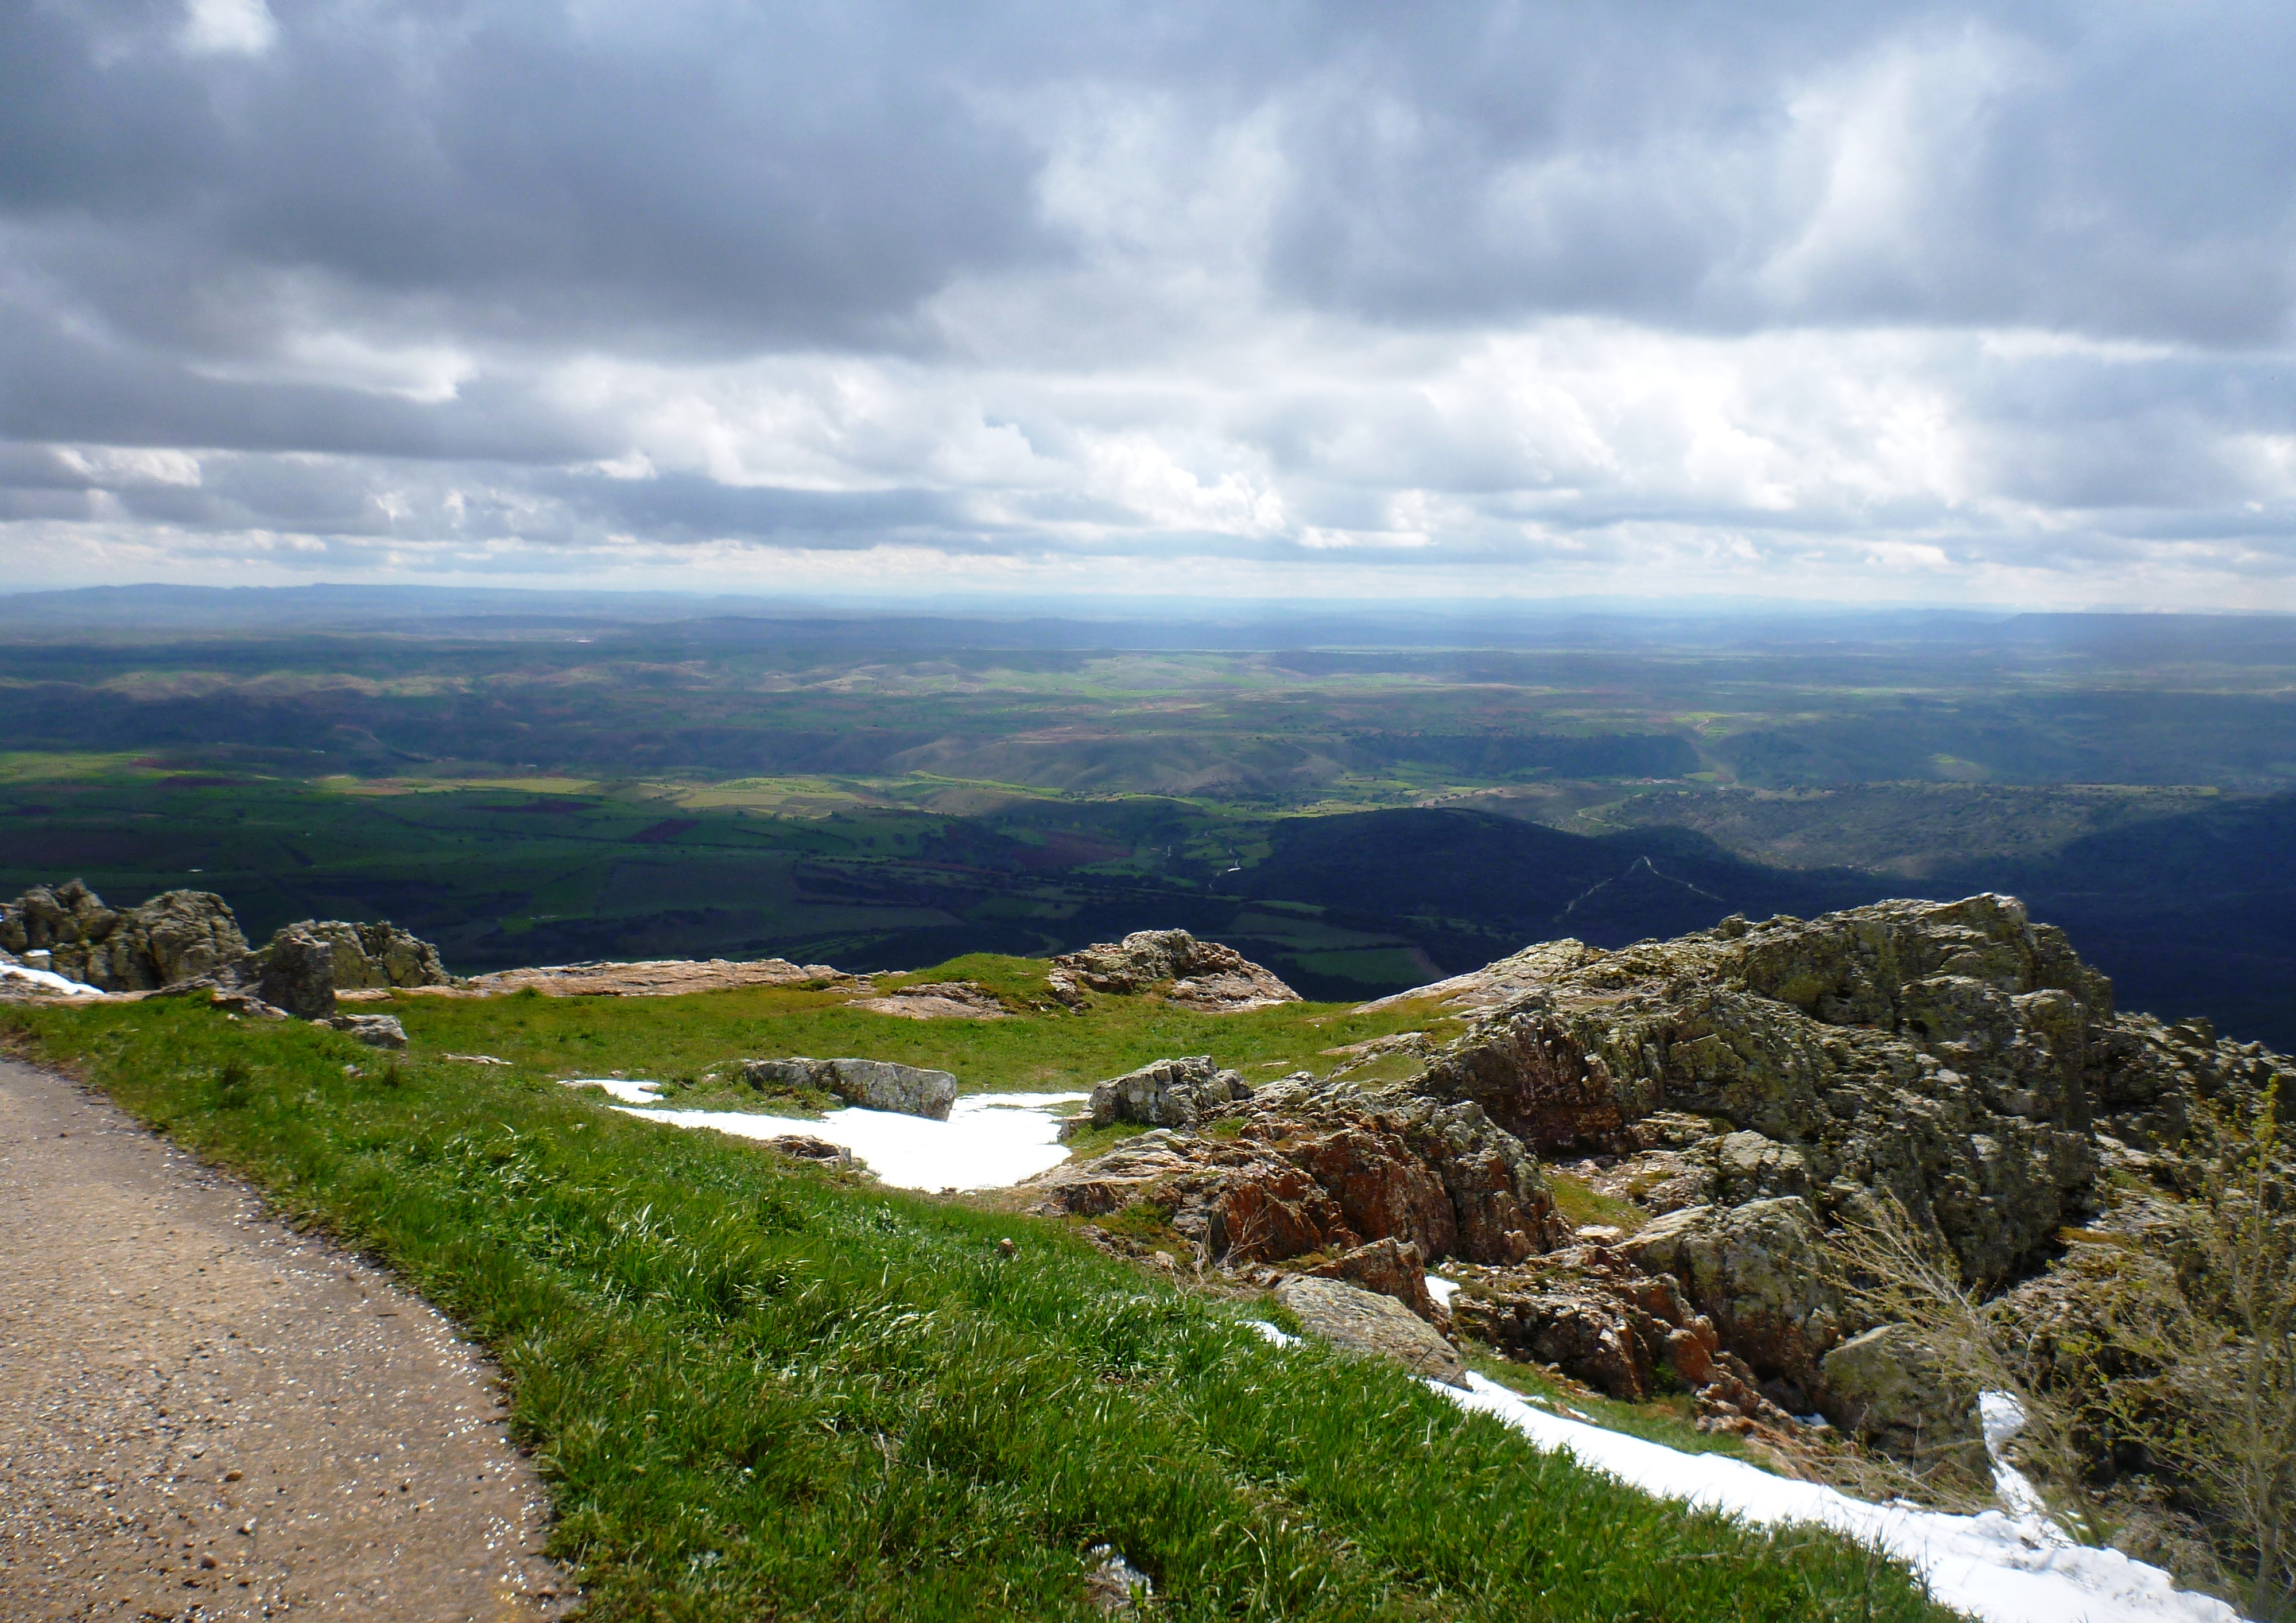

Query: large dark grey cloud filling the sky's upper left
<box><xmin>0</xmin><ymin>5</ymin><xmax>1052</xmax><ymax>342</ymax></box>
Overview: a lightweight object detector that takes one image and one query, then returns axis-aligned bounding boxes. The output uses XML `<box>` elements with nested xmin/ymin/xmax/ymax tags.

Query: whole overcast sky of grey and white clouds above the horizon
<box><xmin>0</xmin><ymin>0</ymin><xmax>2296</xmax><ymax>608</ymax></box>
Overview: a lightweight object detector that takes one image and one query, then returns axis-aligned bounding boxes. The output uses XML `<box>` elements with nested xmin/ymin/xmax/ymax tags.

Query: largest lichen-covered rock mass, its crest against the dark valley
<box><xmin>1424</xmin><ymin>895</ymin><xmax>2174</xmax><ymax>1283</ymax></box>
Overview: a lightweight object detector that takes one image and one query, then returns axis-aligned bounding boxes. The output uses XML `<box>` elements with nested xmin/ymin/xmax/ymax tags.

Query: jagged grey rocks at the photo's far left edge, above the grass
<box><xmin>0</xmin><ymin>879</ymin><xmax>248</xmax><ymax>992</ymax></box>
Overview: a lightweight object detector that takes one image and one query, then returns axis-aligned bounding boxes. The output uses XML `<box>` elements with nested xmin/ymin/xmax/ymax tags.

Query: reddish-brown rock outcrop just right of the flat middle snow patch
<box><xmin>1035</xmin><ymin>1079</ymin><xmax>1561</xmax><ymax>1265</ymax></box>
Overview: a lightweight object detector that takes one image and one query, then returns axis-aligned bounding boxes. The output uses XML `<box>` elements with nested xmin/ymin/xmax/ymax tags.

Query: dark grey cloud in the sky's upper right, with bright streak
<box><xmin>1274</xmin><ymin>5</ymin><xmax>2296</xmax><ymax>342</ymax></box>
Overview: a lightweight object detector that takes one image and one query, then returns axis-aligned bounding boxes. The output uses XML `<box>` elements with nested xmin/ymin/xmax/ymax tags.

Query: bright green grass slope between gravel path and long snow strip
<box><xmin>0</xmin><ymin>999</ymin><xmax>1947</xmax><ymax>1623</ymax></box>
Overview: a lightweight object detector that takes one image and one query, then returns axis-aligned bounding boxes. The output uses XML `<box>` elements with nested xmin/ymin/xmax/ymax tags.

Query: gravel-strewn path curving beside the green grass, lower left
<box><xmin>0</xmin><ymin>1061</ymin><xmax>574</xmax><ymax>1623</ymax></box>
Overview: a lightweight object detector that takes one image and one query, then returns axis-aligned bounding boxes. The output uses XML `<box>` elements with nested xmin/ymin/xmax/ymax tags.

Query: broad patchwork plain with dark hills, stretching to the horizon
<box><xmin>13</xmin><ymin>592</ymin><xmax>2296</xmax><ymax>1042</ymax></box>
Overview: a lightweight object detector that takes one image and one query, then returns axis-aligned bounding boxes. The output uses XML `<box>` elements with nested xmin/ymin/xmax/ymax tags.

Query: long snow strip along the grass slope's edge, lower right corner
<box><xmin>1428</xmin><ymin>1373</ymin><xmax>2241</xmax><ymax>1623</ymax></box>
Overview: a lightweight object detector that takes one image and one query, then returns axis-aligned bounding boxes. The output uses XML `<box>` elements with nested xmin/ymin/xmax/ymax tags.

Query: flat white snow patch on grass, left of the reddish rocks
<box><xmin>597</xmin><ymin>1084</ymin><xmax>1093</xmax><ymax>1189</ymax></box>
